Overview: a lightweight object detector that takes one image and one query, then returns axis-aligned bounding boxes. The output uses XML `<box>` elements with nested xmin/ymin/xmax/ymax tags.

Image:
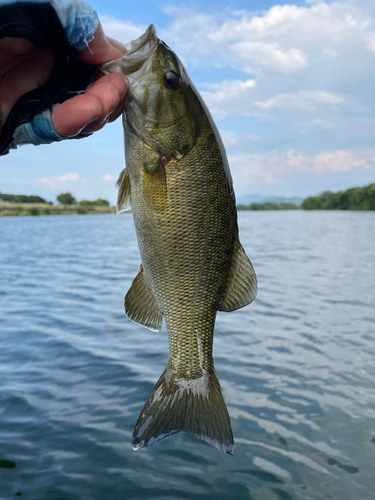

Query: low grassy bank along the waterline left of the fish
<box><xmin>0</xmin><ymin>203</ymin><xmax>116</xmax><ymax>217</ymax></box>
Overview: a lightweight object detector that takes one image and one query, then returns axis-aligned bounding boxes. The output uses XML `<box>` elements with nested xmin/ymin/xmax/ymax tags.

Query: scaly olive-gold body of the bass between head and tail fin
<box><xmin>131</xmin><ymin>116</ymin><xmax>237</xmax><ymax>379</ymax></box>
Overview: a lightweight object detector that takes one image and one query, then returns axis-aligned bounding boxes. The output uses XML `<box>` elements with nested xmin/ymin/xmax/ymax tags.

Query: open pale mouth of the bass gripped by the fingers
<box><xmin>100</xmin><ymin>24</ymin><xmax>159</xmax><ymax>79</ymax></box>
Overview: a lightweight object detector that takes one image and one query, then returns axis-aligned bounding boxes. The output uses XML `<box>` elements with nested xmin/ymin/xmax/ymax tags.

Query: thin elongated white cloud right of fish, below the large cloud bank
<box><xmin>254</xmin><ymin>90</ymin><xmax>343</xmax><ymax>111</ymax></box>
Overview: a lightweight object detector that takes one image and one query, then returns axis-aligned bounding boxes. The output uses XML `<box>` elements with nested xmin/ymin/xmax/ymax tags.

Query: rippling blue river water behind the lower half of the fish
<box><xmin>0</xmin><ymin>211</ymin><xmax>375</xmax><ymax>500</ymax></box>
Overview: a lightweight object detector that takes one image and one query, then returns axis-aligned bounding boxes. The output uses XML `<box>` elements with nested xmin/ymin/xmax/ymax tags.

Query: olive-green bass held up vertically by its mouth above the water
<box><xmin>105</xmin><ymin>25</ymin><xmax>257</xmax><ymax>455</ymax></box>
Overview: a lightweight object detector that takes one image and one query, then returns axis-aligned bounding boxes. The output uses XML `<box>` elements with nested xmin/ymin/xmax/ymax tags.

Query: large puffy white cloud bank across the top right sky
<box><xmin>159</xmin><ymin>1</ymin><xmax>375</xmax><ymax>74</ymax></box>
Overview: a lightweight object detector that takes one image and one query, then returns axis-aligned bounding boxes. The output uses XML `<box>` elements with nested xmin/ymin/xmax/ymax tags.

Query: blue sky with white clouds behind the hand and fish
<box><xmin>0</xmin><ymin>0</ymin><xmax>375</xmax><ymax>203</ymax></box>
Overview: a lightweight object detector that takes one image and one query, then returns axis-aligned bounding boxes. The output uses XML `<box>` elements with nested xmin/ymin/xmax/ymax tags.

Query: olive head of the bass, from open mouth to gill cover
<box><xmin>102</xmin><ymin>25</ymin><xmax>202</xmax><ymax>159</ymax></box>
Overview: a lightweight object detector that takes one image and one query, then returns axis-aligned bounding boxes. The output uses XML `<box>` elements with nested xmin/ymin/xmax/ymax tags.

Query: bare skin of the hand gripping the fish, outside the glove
<box><xmin>0</xmin><ymin>23</ymin><xmax>126</xmax><ymax>137</ymax></box>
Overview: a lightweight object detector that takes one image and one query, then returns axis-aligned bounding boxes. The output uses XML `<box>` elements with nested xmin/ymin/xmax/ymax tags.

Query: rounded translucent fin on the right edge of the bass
<box><xmin>218</xmin><ymin>240</ymin><xmax>258</xmax><ymax>312</ymax></box>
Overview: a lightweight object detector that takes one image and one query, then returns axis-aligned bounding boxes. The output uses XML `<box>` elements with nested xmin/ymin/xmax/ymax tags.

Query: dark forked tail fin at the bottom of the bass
<box><xmin>132</xmin><ymin>367</ymin><xmax>234</xmax><ymax>455</ymax></box>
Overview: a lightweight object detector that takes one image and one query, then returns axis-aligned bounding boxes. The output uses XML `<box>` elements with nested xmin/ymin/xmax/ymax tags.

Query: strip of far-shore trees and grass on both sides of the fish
<box><xmin>0</xmin><ymin>183</ymin><xmax>375</xmax><ymax>216</ymax></box>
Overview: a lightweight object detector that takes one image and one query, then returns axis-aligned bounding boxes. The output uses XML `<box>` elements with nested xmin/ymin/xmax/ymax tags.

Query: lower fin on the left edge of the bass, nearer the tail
<box><xmin>124</xmin><ymin>265</ymin><xmax>163</xmax><ymax>332</ymax></box>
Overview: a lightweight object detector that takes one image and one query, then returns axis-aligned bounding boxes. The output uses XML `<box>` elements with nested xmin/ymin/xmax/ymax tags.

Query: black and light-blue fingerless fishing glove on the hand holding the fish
<box><xmin>0</xmin><ymin>0</ymin><xmax>99</xmax><ymax>156</ymax></box>
